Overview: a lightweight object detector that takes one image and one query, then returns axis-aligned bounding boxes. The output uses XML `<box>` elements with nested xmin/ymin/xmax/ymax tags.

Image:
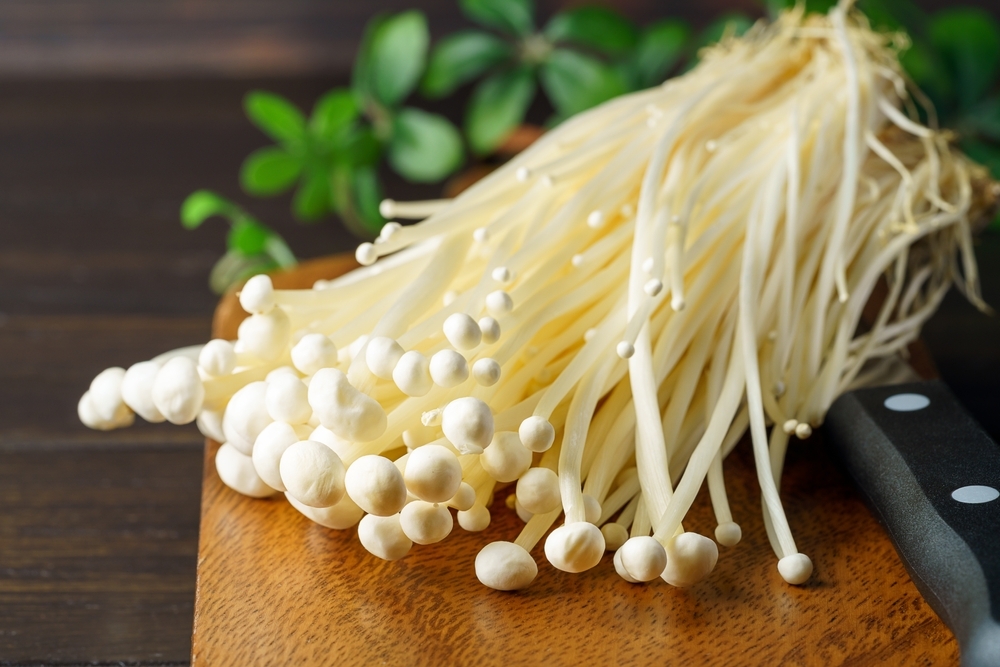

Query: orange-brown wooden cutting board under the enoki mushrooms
<box><xmin>192</xmin><ymin>257</ymin><xmax>958</xmax><ymax>667</ymax></box>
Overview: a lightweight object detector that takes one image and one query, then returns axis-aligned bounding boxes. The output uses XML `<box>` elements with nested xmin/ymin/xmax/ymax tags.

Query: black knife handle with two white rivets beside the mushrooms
<box><xmin>824</xmin><ymin>381</ymin><xmax>1000</xmax><ymax>667</ymax></box>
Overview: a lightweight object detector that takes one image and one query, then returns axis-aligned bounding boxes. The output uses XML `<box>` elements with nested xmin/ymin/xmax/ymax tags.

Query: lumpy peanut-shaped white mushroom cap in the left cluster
<box><xmin>309</xmin><ymin>368</ymin><xmax>387</xmax><ymax>442</ymax></box>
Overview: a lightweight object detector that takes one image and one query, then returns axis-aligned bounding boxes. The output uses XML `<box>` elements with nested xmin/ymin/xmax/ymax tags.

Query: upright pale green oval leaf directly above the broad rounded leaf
<box><xmin>368</xmin><ymin>10</ymin><xmax>430</xmax><ymax>107</ymax></box>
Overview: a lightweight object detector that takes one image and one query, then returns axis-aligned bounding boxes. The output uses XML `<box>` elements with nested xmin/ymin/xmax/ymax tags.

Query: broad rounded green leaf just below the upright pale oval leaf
<box><xmin>389</xmin><ymin>107</ymin><xmax>462</xmax><ymax>183</ymax></box>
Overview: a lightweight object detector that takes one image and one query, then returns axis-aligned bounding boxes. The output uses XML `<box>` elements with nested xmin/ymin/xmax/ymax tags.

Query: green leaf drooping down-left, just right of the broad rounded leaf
<box><xmin>465</xmin><ymin>66</ymin><xmax>535</xmax><ymax>155</ymax></box>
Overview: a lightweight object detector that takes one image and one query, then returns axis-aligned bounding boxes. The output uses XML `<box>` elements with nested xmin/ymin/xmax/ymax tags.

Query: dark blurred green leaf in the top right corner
<box><xmin>930</xmin><ymin>7</ymin><xmax>1000</xmax><ymax>109</ymax></box>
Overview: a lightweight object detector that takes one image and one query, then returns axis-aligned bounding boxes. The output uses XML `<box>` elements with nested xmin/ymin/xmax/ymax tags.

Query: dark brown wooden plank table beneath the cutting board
<box><xmin>0</xmin><ymin>79</ymin><xmax>1000</xmax><ymax>665</ymax></box>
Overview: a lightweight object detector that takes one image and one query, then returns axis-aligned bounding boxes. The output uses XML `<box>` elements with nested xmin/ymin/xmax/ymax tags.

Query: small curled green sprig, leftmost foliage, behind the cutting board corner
<box><xmin>181</xmin><ymin>190</ymin><xmax>296</xmax><ymax>294</ymax></box>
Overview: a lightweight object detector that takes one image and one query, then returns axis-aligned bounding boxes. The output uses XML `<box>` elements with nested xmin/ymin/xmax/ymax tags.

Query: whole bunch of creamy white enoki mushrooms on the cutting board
<box><xmin>79</xmin><ymin>3</ymin><xmax>995</xmax><ymax>590</ymax></box>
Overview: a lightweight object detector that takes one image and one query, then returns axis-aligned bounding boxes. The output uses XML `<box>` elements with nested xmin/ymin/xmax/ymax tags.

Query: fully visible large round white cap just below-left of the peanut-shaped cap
<box><xmin>278</xmin><ymin>440</ymin><xmax>344</xmax><ymax>507</ymax></box>
